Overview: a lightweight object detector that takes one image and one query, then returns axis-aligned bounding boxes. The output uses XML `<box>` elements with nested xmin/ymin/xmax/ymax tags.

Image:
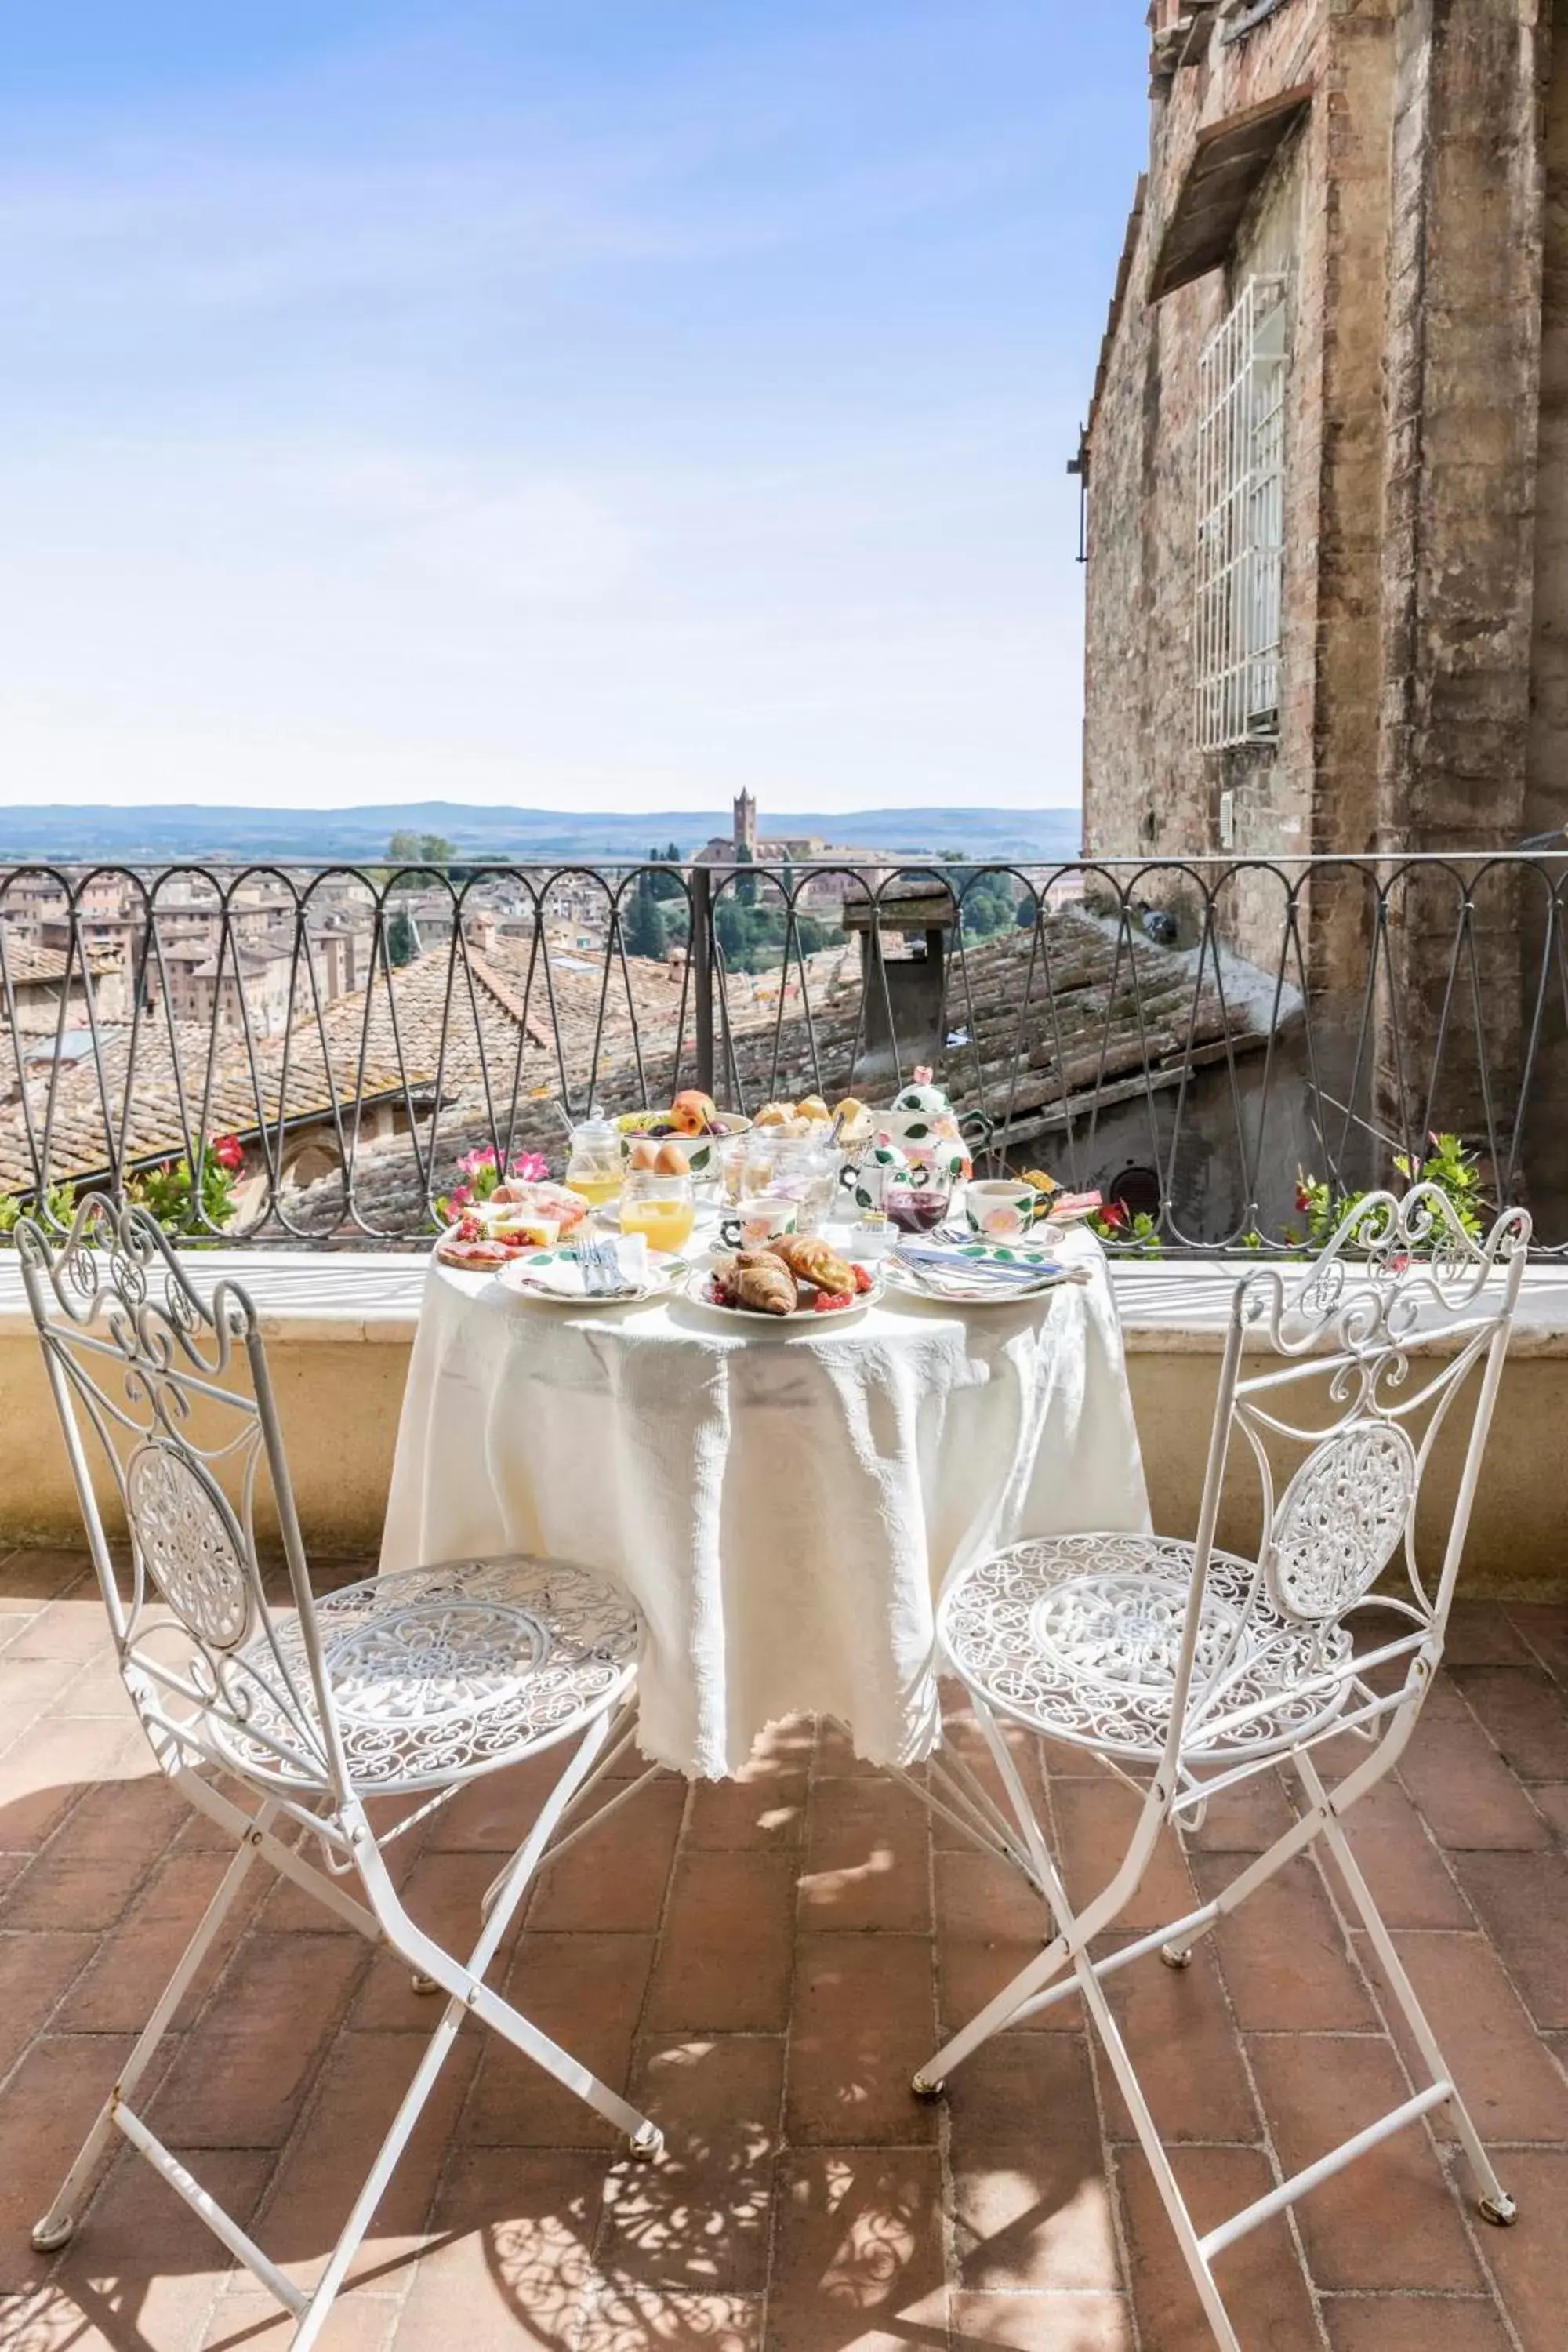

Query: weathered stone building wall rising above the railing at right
<box><xmin>1083</xmin><ymin>0</ymin><xmax>1568</xmax><ymax>884</ymax></box>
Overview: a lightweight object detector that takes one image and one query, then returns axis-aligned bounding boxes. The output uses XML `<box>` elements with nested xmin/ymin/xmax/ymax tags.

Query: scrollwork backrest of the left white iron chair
<box><xmin>16</xmin><ymin>1195</ymin><xmax>346</xmax><ymax>1792</ymax></box>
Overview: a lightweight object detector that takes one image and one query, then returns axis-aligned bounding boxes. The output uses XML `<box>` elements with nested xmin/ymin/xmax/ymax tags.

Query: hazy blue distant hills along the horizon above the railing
<box><xmin>0</xmin><ymin>800</ymin><xmax>1081</xmax><ymax>863</ymax></box>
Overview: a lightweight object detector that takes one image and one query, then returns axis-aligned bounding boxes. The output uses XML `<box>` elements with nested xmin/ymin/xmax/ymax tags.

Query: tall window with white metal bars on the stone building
<box><xmin>1194</xmin><ymin>278</ymin><xmax>1286</xmax><ymax>750</ymax></box>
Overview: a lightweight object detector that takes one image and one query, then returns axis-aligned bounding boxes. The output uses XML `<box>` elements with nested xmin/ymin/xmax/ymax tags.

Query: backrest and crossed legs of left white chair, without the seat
<box><xmin>19</xmin><ymin>1200</ymin><xmax>663</xmax><ymax>2352</ymax></box>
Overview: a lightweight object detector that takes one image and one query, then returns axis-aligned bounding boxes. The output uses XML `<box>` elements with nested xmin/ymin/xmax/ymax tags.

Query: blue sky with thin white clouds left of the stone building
<box><xmin>0</xmin><ymin>0</ymin><xmax>1147</xmax><ymax>809</ymax></box>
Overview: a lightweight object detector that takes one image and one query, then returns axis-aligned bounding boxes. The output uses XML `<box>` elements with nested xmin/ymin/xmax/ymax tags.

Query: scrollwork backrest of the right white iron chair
<box><xmin>1178</xmin><ymin>1185</ymin><xmax>1530</xmax><ymax>1769</ymax></box>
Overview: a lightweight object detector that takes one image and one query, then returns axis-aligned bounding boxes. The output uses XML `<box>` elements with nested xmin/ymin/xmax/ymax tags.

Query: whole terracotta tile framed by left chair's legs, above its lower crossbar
<box><xmin>148</xmin><ymin>1933</ymin><xmax>367</xmax><ymax>2147</ymax></box>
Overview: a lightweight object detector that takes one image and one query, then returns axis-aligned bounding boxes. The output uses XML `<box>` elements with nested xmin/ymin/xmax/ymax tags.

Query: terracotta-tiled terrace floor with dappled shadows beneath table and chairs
<box><xmin>0</xmin><ymin>1552</ymin><xmax>1568</xmax><ymax>2352</ymax></box>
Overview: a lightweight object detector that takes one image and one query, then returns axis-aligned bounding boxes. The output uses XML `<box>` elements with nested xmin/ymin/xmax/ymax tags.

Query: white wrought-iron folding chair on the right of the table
<box><xmin>914</xmin><ymin>1185</ymin><xmax>1530</xmax><ymax>2352</ymax></box>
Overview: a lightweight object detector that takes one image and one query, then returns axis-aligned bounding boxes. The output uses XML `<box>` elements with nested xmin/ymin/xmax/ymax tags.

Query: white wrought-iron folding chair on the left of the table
<box><xmin>16</xmin><ymin>1197</ymin><xmax>663</xmax><ymax>2352</ymax></box>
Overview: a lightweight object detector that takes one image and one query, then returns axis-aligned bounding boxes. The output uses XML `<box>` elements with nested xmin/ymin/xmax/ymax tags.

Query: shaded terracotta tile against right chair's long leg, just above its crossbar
<box><xmin>1100</xmin><ymin>1936</ymin><xmax>1260</xmax><ymax>2143</ymax></box>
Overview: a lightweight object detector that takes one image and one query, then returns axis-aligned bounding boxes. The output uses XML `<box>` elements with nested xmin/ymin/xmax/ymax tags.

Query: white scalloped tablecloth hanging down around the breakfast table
<box><xmin>381</xmin><ymin>1232</ymin><xmax>1149</xmax><ymax>1776</ymax></box>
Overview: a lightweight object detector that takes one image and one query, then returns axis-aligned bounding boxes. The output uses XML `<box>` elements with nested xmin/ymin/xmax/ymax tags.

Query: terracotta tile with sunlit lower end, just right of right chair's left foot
<box><xmin>947</xmin><ymin>2034</ymin><xmax>1121</xmax><ymax>2293</ymax></box>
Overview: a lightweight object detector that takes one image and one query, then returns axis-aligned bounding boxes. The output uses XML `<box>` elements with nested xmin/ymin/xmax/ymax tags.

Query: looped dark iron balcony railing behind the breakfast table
<box><xmin>0</xmin><ymin>854</ymin><xmax>1568</xmax><ymax>1251</ymax></box>
